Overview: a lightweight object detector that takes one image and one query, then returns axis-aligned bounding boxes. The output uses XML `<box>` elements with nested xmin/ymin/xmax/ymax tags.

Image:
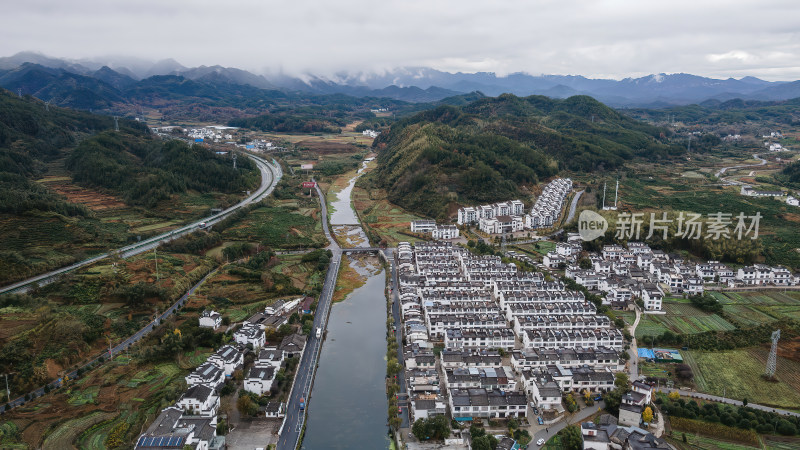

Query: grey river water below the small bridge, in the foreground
<box><xmin>302</xmin><ymin>260</ymin><xmax>389</xmax><ymax>450</ymax></box>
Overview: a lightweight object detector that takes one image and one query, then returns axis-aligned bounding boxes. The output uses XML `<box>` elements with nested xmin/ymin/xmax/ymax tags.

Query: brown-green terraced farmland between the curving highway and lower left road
<box><xmin>0</xmin><ymin>253</ymin><xmax>214</xmax><ymax>403</ymax></box>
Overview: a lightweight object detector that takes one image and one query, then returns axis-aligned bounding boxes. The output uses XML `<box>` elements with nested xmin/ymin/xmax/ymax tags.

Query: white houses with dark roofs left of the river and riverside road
<box><xmin>135</xmin><ymin>298</ymin><xmax>306</xmax><ymax>450</ymax></box>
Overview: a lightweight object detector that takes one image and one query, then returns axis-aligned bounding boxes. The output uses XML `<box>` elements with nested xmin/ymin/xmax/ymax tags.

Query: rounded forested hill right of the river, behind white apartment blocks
<box><xmin>373</xmin><ymin>95</ymin><xmax>683</xmax><ymax>217</ymax></box>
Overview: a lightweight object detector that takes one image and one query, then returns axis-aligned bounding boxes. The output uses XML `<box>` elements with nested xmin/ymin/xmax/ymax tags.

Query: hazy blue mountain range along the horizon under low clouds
<box><xmin>0</xmin><ymin>52</ymin><xmax>800</xmax><ymax>108</ymax></box>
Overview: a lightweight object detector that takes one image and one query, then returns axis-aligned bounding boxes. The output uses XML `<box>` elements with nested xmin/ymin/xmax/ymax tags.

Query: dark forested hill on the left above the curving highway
<box><xmin>0</xmin><ymin>89</ymin><xmax>257</xmax><ymax>216</ymax></box>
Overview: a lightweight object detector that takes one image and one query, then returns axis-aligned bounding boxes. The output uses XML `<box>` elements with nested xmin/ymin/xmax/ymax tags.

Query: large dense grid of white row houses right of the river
<box><xmin>397</xmin><ymin>242</ymin><xmax>624</xmax><ymax>421</ymax></box>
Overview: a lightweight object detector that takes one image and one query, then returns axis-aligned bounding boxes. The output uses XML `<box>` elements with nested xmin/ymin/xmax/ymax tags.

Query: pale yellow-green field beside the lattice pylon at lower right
<box><xmin>681</xmin><ymin>347</ymin><xmax>800</xmax><ymax>409</ymax></box>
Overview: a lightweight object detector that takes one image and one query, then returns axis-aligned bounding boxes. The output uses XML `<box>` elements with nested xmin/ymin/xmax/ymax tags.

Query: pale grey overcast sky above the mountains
<box><xmin>0</xmin><ymin>0</ymin><xmax>800</xmax><ymax>80</ymax></box>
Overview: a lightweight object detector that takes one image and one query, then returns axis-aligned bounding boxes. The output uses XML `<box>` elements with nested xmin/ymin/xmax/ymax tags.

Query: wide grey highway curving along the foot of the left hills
<box><xmin>0</xmin><ymin>154</ymin><xmax>283</xmax><ymax>294</ymax></box>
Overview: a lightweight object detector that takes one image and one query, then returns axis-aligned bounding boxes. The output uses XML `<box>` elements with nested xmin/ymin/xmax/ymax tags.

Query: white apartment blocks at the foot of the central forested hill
<box><xmin>458</xmin><ymin>178</ymin><xmax>572</xmax><ymax>234</ymax></box>
